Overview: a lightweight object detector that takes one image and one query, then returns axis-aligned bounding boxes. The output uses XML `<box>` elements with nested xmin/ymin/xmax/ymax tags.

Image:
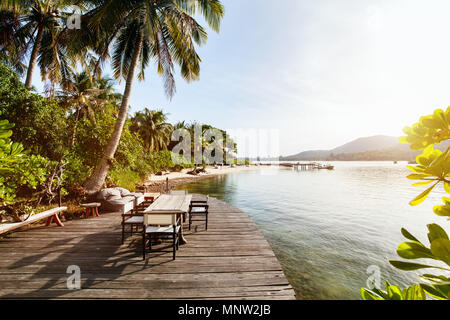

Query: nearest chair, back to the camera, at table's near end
<box><xmin>142</xmin><ymin>213</ymin><xmax>181</xmax><ymax>260</ymax></box>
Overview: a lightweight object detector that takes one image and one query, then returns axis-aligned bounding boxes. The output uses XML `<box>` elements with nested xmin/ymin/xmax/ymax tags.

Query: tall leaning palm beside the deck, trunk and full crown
<box><xmin>84</xmin><ymin>0</ymin><xmax>224</xmax><ymax>193</ymax></box>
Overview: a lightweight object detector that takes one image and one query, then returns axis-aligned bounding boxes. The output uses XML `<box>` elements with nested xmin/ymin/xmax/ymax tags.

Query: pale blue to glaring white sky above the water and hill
<box><xmin>30</xmin><ymin>0</ymin><xmax>450</xmax><ymax>155</ymax></box>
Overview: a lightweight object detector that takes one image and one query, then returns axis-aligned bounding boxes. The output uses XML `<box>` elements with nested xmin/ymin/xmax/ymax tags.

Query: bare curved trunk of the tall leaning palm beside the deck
<box><xmin>84</xmin><ymin>31</ymin><xmax>144</xmax><ymax>194</ymax></box>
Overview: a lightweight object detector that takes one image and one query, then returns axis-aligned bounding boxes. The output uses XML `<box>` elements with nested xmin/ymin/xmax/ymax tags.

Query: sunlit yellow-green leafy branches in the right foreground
<box><xmin>361</xmin><ymin>107</ymin><xmax>450</xmax><ymax>300</ymax></box>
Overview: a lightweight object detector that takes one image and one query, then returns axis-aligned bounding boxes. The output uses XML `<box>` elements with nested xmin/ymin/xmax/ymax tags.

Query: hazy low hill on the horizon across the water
<box><xmin>280</xmin><ymin>135</ymin><xmax>449</xmax><ymax>161</ymax></box>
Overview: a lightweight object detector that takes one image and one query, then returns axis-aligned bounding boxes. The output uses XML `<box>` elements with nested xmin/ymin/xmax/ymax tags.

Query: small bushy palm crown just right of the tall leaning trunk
<box><xmin>130</xmin><ymin>108</ymin><xmax>173</xmax><ymax>152</ymax></box>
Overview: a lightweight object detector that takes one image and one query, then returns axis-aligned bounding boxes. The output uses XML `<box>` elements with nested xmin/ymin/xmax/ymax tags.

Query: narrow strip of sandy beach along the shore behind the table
<box><xmin>144</xmin><ymin>166</ymin><xmax>265</xmax><ymax>192</ymax></box>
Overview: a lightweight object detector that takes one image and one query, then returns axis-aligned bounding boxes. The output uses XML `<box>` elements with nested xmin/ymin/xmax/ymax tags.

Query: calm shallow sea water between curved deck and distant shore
<box><xmin>176</xmin><ymin>162</ymin><xmax>447</xmax><ymax>299</ymax></box>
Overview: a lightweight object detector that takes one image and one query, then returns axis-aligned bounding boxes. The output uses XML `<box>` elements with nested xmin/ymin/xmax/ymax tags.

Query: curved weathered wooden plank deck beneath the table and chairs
<box><xmin>0</xmin><ymin>198</ymin><xmax>295</xmax><ymax>300</ymax></box>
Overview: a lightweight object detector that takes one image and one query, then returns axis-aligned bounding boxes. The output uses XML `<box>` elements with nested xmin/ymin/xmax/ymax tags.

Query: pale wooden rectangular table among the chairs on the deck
<box><xmin>144</xmin><ymin>194</ymin><xmax>192</xmax><ymax>244</ymax></box>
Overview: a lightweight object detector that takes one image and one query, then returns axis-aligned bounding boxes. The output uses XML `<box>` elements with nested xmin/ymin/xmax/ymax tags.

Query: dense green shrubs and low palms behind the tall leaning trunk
<box><xmin>0</xmin><ymin>57</ymin><xmax>232</xmax><ymax>215</ymax></box>
